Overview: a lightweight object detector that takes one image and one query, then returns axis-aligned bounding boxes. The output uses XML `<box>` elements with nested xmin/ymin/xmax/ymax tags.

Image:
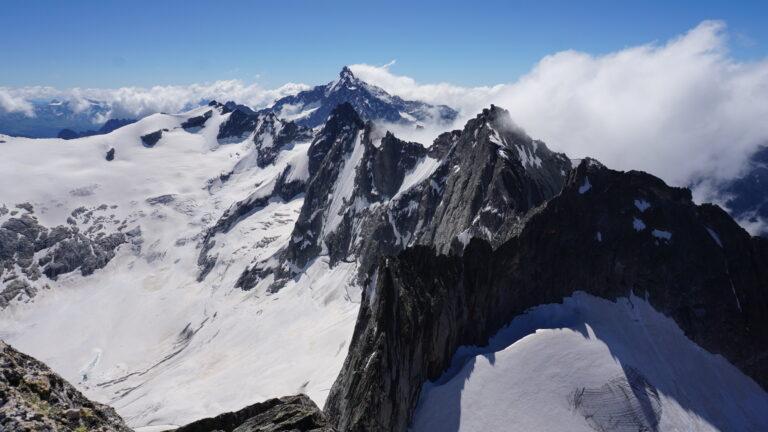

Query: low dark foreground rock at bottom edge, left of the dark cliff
<box><xmin>175</xmin><ymin>394</ymin><xmax>334</xmax><ymax>432</ymax></box>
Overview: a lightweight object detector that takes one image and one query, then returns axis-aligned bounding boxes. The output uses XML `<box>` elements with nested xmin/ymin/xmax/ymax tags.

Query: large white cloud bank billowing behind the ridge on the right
<box><xmin>351</xmin><ymin>21</ymin><xmax>768</xmax><ymax>185</ymax></box>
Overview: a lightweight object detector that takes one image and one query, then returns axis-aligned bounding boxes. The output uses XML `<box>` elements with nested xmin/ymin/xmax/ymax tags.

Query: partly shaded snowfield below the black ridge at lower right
<box><xmin>411</xmin><ymin>293</ymin><xmax>768</xmax><ymax>432</ymax></box>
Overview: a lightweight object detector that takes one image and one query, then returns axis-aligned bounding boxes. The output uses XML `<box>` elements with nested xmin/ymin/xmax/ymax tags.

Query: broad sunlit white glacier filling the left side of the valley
<box><xmin>0</xmin><ymin>107</ymin><xmax>359</xmax><ymax>428</ymax></box>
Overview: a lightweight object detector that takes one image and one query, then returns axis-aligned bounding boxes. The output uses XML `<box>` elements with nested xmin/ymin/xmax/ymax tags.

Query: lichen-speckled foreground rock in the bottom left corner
<box><xmin>0</xmin><ymin>341</ymin><xmax>131</xmax><ymax>432</ymax></box>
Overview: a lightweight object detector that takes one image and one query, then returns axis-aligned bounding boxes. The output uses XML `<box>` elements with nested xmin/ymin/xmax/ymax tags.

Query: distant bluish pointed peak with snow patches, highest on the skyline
<box><xmin>262</xmin><ymin>66</ymin><xmax>457</xmax><ymax>127</ymax></box>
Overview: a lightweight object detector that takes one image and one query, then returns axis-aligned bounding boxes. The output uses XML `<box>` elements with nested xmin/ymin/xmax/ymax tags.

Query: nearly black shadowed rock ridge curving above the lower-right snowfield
<box><xmin>325</xmin><ymin>160</ymin><xmax>768</xmax><ymax>431</ymax></box>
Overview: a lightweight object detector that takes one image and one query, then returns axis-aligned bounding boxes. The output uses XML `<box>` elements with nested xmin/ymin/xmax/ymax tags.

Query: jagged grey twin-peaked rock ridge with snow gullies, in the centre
<box><xmin>238</xmin><ymin>104</ymin><xmax>570</xmax><ymax>289</ymax></box>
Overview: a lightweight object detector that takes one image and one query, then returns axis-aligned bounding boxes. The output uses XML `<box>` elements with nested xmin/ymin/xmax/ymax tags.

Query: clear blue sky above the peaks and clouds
<box><xmin>0</xmin><ymin>0</ymin><xmax>768</xmax><ymax>88</ymax></box>
